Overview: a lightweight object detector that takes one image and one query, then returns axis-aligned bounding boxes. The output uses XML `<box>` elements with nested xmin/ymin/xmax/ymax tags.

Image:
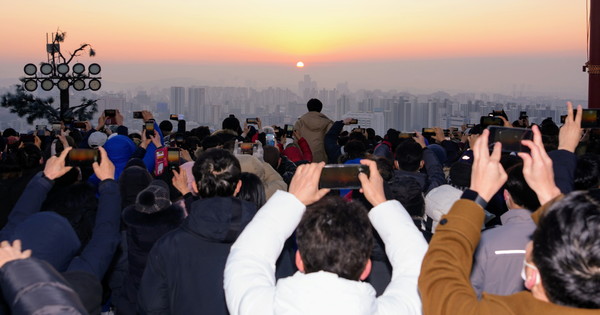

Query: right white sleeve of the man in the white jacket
<box><xmin>369</xmin><ymin>200</ymin><xmax>428</xmax><ymax>314</ymax></box>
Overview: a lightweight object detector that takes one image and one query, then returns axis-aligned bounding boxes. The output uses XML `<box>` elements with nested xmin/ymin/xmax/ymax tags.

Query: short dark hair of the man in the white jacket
<box><xmin>296</xmin><ymin>196</ymin><xmax>373</xmax><ymax>280</ymax></box>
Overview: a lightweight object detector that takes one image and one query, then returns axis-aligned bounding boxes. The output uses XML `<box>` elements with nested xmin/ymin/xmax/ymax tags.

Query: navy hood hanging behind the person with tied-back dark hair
<box><xmin>181</xmin><ymin>197</ymin><xmax>257</xmax><ymax>243</ymax></box>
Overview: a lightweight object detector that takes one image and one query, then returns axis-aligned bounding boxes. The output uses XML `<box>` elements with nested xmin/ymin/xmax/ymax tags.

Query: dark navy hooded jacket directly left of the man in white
<box><xmin>138</xmin><ymin>197</ymin><xmax>256</xmax><ymax>314</ymax></box>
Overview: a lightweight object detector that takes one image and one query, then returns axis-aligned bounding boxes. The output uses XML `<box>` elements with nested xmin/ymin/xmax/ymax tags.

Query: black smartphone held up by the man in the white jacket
<box><xmin>319</xmin><ymin>164</ymin><xmax>369</xmax><ymax>189</ymax></box>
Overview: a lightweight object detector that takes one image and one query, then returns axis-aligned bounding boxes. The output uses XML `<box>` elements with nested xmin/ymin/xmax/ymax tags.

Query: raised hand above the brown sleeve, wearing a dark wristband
<box><xmin>471</xmin><ymin>129</ymin><xmax>508</xmax><ymax>202</ymax></box>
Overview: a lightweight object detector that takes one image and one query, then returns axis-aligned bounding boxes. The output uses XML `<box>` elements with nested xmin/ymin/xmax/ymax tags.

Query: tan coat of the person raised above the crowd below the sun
<box><xmin>294</xmin><ymin>112</ymin><xmax>333</xmax><ymax>163</ymax></box>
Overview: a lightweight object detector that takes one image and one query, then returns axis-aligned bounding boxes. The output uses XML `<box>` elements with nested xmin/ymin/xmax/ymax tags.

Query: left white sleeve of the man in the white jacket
<box><xmin>223</xmin><ymin>191</ymin><xmax>306</xmax><ymax>315</ymax></box>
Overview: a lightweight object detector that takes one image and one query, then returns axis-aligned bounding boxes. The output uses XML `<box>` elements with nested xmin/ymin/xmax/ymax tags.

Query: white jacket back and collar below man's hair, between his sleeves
<box><xmin>274</xmin><ymin>271</ymin><xmax>377</xmax><ymax>314</ymax></box>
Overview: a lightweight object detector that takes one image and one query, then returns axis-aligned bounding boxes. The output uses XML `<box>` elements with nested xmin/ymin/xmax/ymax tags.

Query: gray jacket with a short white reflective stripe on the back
<box><xmin>471</xmin><ymin>209</ymin><xmax>536</xmax><ymax>297</ymax></box>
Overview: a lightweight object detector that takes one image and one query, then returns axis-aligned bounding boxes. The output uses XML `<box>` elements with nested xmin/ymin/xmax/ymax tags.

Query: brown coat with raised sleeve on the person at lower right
<box><xmin>419</xmin><ymin>199</ymin><xmax>600</xmax><ymax>315</ymax></box>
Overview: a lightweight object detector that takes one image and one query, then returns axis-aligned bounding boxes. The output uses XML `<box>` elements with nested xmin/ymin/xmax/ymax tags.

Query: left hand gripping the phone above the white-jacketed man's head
<box><xmin>289</xmin><ymin>162</ymin><xmax>329</xmax><ymax>206</ymax></box>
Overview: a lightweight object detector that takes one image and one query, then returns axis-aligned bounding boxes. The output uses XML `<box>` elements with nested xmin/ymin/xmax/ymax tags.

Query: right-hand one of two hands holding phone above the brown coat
<box><xmin>519</xmin><ymin>124</ymin><xmax>560</xmax><ymax>205</ymax></box>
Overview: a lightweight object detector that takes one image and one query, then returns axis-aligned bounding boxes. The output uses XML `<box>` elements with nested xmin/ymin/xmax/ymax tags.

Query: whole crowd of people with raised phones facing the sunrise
<box><xmin>0</xmin><ymin>99</ymin><xmax>600</xmax><ymax>314</ymax></box>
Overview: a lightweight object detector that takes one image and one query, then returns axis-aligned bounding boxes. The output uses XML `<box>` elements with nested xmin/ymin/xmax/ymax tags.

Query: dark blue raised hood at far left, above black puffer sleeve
<box><xmin>11</xmin><ymin>211</ymin><xmax>81</xmax><ymax>272</ymax></box>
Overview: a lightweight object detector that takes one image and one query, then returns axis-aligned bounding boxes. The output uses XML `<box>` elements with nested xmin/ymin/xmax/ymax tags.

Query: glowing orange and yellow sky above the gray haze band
<box><xmin>0</xmin><ymin>0</ymin><xmax>586</xmax><ymax>66</ymax></box>
